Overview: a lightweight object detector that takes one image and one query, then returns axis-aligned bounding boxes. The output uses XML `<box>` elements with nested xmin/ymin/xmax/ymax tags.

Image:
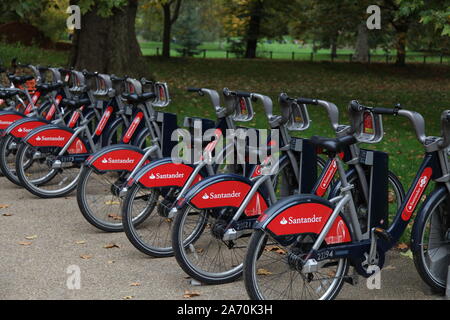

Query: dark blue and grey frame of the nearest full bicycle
<box><xmin>284</xmin><ymin>110</ymin><xmax>450</xmax><ymax>277</ymax></box>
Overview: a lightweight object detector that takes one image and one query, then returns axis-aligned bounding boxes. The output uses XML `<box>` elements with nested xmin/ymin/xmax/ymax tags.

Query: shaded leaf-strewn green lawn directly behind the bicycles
<box><xmin>0</xmin><ymin>42</ymin><xmax>450</xmax><ymax>241</ymax></box>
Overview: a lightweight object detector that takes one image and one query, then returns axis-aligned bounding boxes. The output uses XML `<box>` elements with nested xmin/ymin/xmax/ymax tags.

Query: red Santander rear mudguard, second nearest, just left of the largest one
<box><xmin>179</xmin><ymin>174</ymin><xmax>268</xmax><ymax>216</ymax></box>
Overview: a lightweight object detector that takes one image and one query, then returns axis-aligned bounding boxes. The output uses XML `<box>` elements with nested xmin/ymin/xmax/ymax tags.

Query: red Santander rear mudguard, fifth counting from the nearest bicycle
<box><xmin>23</xmin><ymin>124</ymin><xmax>88</xmax><ymax>154</ymax></box>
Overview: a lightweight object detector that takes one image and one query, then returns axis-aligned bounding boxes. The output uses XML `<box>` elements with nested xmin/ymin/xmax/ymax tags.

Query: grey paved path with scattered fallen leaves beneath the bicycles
<box><xmin>0</xmin><ymin>177</ymin><xmax>442</xmax><ymax>300</ymax></box>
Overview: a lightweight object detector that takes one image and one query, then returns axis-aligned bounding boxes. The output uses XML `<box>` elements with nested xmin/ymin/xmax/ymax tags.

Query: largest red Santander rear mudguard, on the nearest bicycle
<box><xmin>254</xmin><ymin>195</ymin><xmax>352</xmax><ymax>245</ymax></box>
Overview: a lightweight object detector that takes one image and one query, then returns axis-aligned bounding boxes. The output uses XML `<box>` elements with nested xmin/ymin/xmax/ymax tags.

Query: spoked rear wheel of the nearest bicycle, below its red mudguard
<box><xmin>244</xmin><ymin>230</ymin><xmax>349</xmax><ymax>300</ymax></box>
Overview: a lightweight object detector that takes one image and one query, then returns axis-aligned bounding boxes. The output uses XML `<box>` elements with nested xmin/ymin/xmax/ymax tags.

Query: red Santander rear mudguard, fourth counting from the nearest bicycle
<box><xmin>85</xmin><ymin>144</ymin><xmax>149</xmax><ymax>172</ymax></box>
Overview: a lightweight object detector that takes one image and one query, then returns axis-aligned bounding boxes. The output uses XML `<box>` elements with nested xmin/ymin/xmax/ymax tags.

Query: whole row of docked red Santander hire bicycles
<box><xmin>0</xmin><ymin>63</ymin><xmax>450</xmax><ymax>300</ymax></box>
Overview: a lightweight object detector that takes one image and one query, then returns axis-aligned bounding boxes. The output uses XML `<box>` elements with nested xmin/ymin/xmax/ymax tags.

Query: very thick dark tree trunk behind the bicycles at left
<box><xmin>69</xmin><ymin>0</ymin><xmax>151</xmax><ymax>78</ymax></box>
